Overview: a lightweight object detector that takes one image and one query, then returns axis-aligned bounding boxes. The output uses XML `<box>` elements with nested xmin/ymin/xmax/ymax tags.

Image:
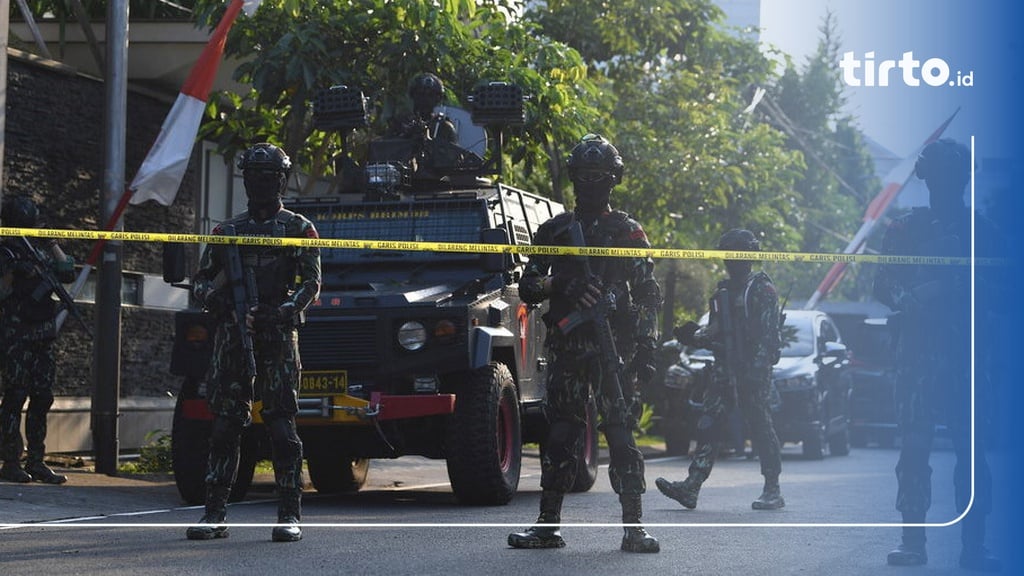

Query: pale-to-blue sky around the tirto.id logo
<box><xmin>761</xmin><ymin>0</ymin><xmax>1021</xmax><ymax>156</ymax></box>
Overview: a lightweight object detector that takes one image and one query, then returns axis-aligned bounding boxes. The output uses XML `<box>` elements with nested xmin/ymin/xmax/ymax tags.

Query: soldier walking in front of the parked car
<box><xmin>654</xmin><ymin>230</ymin><xmax>785</xmax><ymax>510</ymax></box>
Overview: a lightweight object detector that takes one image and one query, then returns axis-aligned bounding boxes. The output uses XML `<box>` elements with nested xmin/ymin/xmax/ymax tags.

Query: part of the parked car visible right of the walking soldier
<box><xmin>772</xmin><ymin>310</ymin><xmax>852</xmax><ymax>459</ymax></box>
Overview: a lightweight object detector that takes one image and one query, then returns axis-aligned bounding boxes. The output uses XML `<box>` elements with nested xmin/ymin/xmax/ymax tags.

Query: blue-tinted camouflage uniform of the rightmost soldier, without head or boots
<box><xmin>874</xmin><ymin>204</ymin><xmax>997</xmax><ymax>563</ymax></box>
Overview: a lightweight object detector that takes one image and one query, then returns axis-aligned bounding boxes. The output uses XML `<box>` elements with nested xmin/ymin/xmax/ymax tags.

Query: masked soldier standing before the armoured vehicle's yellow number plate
<box><xmin>186</xmin><ymin>143</ymin><xmax>321</xmax><ymax>542</ymax></box>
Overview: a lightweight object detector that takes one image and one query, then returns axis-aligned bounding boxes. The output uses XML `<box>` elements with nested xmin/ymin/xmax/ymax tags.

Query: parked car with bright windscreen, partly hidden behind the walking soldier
<box><xmin>654</xmin><ymin>310</ymin><xmax>851</xmax><ymax>459</ymax></box>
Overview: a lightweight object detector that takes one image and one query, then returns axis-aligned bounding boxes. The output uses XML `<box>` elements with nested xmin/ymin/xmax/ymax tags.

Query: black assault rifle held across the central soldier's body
<box><xmin>558</xmin><ymin>219</ymin><xmax>630</xmax><ymax>428</ymax></box>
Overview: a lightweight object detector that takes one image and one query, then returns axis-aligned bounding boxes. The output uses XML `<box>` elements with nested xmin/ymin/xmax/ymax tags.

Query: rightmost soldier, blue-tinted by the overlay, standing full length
<box><xmin>874</xmin><ymin>138</ymin><xmax>1001</xmax><ymax>571</ymax></box>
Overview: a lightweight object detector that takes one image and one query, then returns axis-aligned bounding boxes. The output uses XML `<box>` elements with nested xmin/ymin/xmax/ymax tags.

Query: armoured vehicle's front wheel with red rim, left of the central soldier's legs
<box><xmin>445</xmin><ymin>362</ymin><xmax>522</xmax><ymax>505</ymax></box>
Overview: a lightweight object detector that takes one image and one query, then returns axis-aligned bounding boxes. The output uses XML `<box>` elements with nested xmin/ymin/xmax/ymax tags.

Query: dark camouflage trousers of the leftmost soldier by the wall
<box><xmin>0</xmin><ymin>339</ymin><xmax>56</xmax><ymax>462</ymax></box>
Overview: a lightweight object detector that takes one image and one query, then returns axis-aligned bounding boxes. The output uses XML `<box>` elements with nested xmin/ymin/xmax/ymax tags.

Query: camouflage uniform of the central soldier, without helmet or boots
<box><xmin>519</xmin><ymin>211</ymin><xmax>660</xmax><ymax>494</ymax></box>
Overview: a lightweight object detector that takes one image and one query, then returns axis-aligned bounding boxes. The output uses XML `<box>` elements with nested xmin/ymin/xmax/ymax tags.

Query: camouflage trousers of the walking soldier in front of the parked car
<box><xmin>689</xmin><ymin>364</ymin><xmax>782</xmax><ymax>482</ymax></box>
